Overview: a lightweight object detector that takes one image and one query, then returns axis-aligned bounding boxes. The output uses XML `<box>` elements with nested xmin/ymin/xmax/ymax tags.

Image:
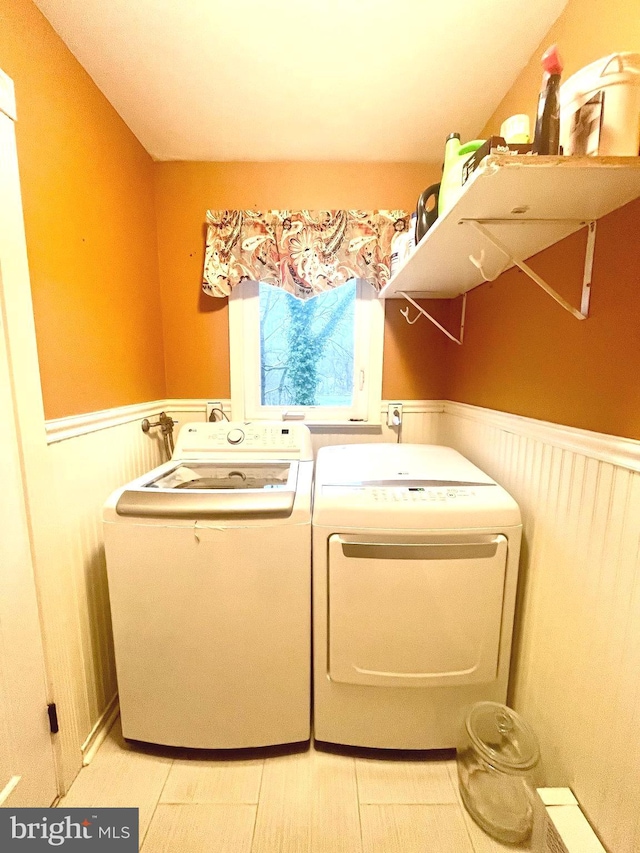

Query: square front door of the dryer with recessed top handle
<box><xmin>328</xmin><ymin>534</ymin><xmax>507</xmax><ymax>687</ymax></box>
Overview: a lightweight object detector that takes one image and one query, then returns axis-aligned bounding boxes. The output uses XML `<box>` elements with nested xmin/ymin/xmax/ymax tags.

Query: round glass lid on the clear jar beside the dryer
<box><xmin>465</xmin><ymin>702</ymin><xmax>540</xmax><ymax>772</ymax></box>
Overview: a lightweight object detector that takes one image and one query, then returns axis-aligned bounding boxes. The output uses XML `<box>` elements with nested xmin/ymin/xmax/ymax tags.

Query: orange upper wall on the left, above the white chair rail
<box><xmin>0</xmin><ymin>0</ymin><xmax>165</xmax><ymax>418</ymax></box>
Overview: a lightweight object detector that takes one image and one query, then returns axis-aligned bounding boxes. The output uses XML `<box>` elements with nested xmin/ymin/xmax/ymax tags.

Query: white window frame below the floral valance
<box><xmin>229</xmin><ymin>279</ymin><xmax>384</xmax><ymax>426</ymax></box>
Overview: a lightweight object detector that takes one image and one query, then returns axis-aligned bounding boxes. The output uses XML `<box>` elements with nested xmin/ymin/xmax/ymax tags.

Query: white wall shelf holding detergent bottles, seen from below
<box><xmin>379</xmin><ymin>155</ymin><xmax>640</xmax><ymax>299</ymax></box>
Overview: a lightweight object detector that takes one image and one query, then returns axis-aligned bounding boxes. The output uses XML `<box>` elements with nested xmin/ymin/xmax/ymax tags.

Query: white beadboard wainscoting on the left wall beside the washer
<box><xmin>48</xmin><ymin>419</ymin><xmax>163</xmax><ymax>751</ymax></box>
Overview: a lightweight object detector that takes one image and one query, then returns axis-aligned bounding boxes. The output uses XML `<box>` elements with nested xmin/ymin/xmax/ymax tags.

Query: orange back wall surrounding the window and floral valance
<box><xmin>155</xmin><ymin>163</ymin><xmax>445</xmax><ymax>399</ymax></box>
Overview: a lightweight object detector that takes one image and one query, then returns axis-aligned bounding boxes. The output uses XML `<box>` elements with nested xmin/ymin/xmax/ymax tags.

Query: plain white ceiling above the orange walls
<box><xmin>36</xmin><ymin>0</ymin><xmax>567</xmax><ymax>161</ymax></box>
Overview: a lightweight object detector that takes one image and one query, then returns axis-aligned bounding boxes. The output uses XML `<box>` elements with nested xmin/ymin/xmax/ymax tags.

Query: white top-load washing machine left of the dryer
<box><xmin>104</xmin><ymin>422</ymin><xmax>313</xmax><ymax>749</ymax></box>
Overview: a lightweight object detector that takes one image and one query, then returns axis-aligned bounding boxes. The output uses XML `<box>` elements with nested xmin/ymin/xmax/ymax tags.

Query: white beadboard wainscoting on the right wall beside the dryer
<box><xmin>439</xmin><ymin>403</ymin><xmax>640</xmax><ymax>853</ymax></box>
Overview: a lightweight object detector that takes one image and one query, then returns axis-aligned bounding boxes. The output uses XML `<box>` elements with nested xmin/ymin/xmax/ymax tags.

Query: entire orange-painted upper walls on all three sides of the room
<box><xmin>6</xmin><ymin>0</ymin><xmax>640</xmax><ymax>438</ymax></box>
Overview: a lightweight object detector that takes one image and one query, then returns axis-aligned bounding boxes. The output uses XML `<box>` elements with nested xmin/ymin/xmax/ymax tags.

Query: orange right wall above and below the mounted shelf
<box><xmin>446</xmin><ymin>0</ymin><xmax>640</xmax><ymax>439</ymax></box>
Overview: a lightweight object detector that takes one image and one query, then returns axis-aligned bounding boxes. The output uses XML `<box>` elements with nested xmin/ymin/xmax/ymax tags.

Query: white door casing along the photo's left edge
<box><xmin>0</xmin><ymin>69</ymin><xmax>88</xmax><ymax>793</ymax></box>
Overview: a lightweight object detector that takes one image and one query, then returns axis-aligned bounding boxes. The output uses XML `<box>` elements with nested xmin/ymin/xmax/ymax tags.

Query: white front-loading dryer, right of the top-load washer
<box><xmin>312</xmin><ymin>444</ymin><xmax>521</xmax><ymax>749</ymax></box>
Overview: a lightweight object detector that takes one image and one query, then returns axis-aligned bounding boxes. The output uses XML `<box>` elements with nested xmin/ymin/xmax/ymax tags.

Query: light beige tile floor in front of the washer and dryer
<box><xmin>60</xmin><ymin>721</ymin><xmax>526</xmax><ymax>853</ymax></box>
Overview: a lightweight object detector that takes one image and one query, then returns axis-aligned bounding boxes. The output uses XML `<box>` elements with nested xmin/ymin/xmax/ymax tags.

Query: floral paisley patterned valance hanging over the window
<box><xmin>202</xmin><ymin>210</ymin><xmax>409</xmax><ymax>299</ymax></box>
